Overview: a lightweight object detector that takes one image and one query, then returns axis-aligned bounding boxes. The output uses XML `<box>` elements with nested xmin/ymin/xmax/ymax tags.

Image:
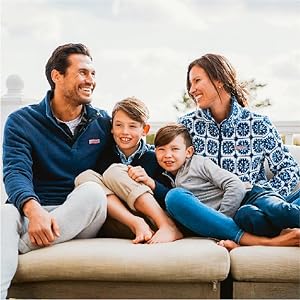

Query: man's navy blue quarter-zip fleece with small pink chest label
<box><xmin>3</xmin><ymin>91</ymin><xmax>112</xmax><ymax>211</ymax></box>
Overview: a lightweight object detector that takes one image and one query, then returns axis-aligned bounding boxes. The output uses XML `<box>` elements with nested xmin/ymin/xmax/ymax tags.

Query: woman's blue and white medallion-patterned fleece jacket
<box><xmin>179</xmin><ymin>98</ymin><xmax>300</xmax><ymax>196</ymax></box>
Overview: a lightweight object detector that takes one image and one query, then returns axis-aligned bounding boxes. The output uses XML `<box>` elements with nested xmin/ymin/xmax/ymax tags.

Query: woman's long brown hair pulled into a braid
<box><xmin>186</xmin><ymin>54</ymin><xmax>249</xmax><ymax>107</ymax></box>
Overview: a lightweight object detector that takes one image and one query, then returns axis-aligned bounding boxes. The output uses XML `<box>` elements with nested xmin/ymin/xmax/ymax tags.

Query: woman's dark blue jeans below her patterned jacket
<box><xmin>233</xmin><ymin>186</ymin><xmax>300</xmax><ymax>237</ymax></box>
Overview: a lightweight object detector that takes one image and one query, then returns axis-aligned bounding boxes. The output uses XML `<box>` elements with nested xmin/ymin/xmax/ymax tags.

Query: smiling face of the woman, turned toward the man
<box><xmin>189</xmin><ymin>66</ymin><xmax>222</xmax><ymax>109</ymax></box>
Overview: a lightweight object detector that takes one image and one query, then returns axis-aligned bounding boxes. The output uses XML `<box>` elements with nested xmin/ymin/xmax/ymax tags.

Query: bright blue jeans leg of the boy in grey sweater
<box><xmin>165</xmin><ymin>188</ymin><xmax>244</xmax><ymax>243</ymax></box>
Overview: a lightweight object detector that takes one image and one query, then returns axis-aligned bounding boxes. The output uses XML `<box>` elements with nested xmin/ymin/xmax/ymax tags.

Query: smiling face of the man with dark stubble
<box><xmin>55</xmin><ymin>54</ymin><xmax>96</xmax><ymax>105</ymax></box>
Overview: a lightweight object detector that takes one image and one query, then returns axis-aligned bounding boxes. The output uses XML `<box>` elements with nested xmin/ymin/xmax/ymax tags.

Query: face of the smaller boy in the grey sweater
<box><xmin>155</xmin><ymin>135</ymin><xmax>194</xmax><ymax>175</ymax></box>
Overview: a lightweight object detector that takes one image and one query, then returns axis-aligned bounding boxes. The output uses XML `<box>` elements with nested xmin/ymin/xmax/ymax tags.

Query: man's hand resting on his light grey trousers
<box><xmin>23</xmin><ymin>199</ymin><xmax>60</xmax><ymax>247</ymax></box>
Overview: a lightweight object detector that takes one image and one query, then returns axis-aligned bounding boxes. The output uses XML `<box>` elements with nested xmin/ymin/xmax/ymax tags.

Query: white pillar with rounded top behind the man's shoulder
<box><xmin>0</xmin><ymin>74</ymin><xmax>24</xmax><ymax>203</ymax></box>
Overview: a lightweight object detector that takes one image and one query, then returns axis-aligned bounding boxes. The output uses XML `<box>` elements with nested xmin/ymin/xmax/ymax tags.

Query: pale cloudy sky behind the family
<box><xmin>1</xmin><ymin>0</ymin><xmax>300</xmax><ymax>122</ymax></box>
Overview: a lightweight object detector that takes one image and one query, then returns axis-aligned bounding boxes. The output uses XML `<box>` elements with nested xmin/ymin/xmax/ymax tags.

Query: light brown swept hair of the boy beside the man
<box><xmin>112</xmin><ymin>97</ymin><xmax>149</xmax><ymax>125</ymax></box>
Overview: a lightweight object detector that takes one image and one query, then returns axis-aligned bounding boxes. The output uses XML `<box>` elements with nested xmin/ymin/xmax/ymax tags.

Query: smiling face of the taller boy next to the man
<box><xmin>111</xmin><ymin>110</ymin><xmax>150</xmax><ymax>157</ymax></box>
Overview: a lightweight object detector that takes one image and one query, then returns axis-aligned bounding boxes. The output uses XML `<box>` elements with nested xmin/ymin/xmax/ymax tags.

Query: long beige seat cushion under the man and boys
<box><xmin>14</xmin><ymin>238</ymin><xmax>230</xmax><ymax>282</ymax></box>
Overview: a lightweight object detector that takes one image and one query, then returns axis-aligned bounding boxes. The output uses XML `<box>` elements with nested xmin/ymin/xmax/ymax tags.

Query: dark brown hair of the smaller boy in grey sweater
<box><xmin>154</xmin><ymin>124</ymin><xmax>193</xmax><ymax>148</ymax></box>
